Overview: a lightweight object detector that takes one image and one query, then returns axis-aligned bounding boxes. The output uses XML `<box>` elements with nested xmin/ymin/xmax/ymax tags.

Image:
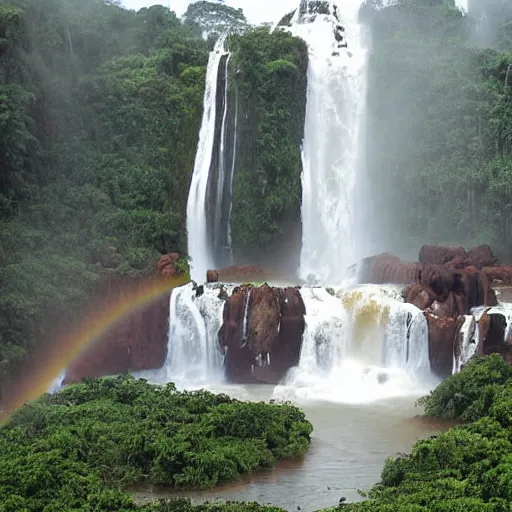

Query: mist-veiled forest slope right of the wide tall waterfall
<box><xmin>361</xmin><ymin>0</ymin><xmax>512</xmax><ymax>259</ymax></box>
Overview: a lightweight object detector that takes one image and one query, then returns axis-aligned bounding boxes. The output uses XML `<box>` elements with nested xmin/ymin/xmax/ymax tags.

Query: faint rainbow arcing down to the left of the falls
<box><xmin>0</xmin><ymin>276</ymin><xmax>189</xmax><ymax>425</ymax></box>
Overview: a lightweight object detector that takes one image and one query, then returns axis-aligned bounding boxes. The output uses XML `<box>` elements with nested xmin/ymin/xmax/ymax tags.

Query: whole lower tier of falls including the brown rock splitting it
<box><xmin>145</xmin><ymin>283</ymin><xmax>430</xmax><ymax>402</ymax></box>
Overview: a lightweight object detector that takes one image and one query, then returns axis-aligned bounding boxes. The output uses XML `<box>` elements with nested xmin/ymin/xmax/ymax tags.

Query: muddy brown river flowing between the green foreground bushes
<box><xmin>132</xmin><ymin>386</ymin><xmax>450</xmax><ymax>512</ymax></box>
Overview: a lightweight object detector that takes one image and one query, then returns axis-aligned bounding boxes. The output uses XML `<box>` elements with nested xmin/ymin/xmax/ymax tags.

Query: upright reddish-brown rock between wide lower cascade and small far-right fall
<box><xmin>425</xmin><ymin>313</ymin><xmax>464</xmax><ymax>378</ymax></box>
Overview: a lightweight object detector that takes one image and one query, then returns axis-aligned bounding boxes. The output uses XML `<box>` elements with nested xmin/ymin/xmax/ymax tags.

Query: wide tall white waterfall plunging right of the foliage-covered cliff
<box><xmin>291</xmin><ymin>0</ymin><xmax>368</xmax><ymax>284</ymax></box>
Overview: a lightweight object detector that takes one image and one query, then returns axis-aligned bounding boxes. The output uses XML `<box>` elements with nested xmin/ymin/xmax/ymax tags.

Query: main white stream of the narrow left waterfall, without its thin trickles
<box><xmin>187</xmin><ymin>37</ymin><xmax>227</xmax><ymax>282</ymax></box>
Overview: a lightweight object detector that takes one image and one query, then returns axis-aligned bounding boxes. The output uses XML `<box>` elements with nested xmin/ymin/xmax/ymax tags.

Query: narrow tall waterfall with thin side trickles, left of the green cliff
<box><xmin>187</xmin><ymin>37</ymin><xmax>236</xmax><ymax>282</ymax></box>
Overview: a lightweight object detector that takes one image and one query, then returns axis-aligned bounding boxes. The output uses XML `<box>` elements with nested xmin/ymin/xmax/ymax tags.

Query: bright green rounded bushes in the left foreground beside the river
<box><xmin>0</xmin><ymin>376</ymin><xmax>312</xmax><ymax>512</ymax></box>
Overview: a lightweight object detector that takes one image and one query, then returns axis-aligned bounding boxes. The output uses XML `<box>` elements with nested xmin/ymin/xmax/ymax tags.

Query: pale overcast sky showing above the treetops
<box><xmin>121</xmin><ymin>0</ymin><xmax>467</xmax><ymax>23</ymax></box>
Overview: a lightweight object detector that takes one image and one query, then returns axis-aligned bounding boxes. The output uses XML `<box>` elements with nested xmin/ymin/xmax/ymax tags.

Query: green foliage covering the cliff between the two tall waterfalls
<box><xmin>230</xmin><ymin>28</ymin><xmax>308</xmax><ymax>255</ymax></box>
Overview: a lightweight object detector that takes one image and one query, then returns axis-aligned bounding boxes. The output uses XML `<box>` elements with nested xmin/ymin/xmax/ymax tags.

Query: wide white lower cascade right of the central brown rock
<box><xmin>275</xmin><ymin>286</ymin><xmax>430</xmax><ymax>403</ymax></box>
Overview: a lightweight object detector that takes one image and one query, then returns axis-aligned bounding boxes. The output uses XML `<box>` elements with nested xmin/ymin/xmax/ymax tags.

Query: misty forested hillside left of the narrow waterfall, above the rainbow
<box><xmin>0</xmin><ymin>0</ymin><xmax>208</xmax><ymax>394</ymax></box>
